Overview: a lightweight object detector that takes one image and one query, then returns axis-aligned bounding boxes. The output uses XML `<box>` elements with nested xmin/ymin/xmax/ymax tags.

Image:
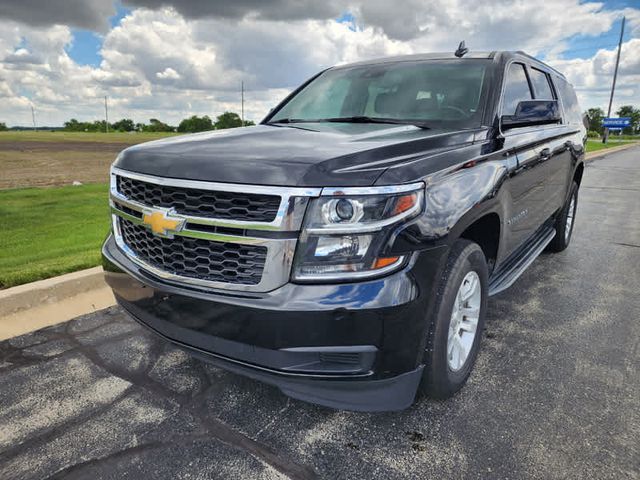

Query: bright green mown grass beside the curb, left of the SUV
<box><xmin>0</xmin><ymin>184</ymin><xmax>109</xmax><ymax>288</ymax></box>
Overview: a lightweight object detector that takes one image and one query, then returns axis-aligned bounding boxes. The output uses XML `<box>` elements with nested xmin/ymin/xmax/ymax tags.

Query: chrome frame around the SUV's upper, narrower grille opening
<box><xmin>110</xmin><ymin>167</ymin><xmax>322</xmax><ymax>231</ymax></box>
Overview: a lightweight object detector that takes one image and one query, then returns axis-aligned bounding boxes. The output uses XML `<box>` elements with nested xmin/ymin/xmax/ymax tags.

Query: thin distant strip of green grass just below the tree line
<box><xmin>0</xmin><ymin>131</ymin><xmax>178</xmax><ymax>145</ymax></box>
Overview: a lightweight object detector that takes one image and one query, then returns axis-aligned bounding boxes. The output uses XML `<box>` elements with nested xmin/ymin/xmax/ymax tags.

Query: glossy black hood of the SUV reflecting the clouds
<box><xmin>114</xmin><ymin>123</ymin><xmax>473</xmax><ymax>187</ymax></box>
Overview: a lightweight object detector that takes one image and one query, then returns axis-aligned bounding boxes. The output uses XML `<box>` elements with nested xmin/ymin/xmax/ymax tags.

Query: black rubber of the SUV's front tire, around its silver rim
<box><xmin>420</xmin><ymin>240</ymin><xmax>489</xmax><ymax>398</ymax></box>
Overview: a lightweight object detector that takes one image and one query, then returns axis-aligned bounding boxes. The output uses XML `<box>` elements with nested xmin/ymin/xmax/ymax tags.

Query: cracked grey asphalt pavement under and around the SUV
<box><xmin>0</xmin><ymin>147</ymin><xmax>640</xmax><ymax>479</ymax></box>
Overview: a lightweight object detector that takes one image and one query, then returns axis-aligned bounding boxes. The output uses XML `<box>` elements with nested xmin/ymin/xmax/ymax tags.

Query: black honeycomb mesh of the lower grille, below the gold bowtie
<box><xmin>119</xmin><ymin>218</ymin><xmax>267</xmax><ymax>285</ymax></box>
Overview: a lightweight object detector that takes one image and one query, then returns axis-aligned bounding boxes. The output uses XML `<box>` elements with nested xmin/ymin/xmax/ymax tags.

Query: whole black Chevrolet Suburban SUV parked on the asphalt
<box><xmin>103</xmin><ymin>52</ymin><xmax>586</xmax><ymax>410</ymax></box>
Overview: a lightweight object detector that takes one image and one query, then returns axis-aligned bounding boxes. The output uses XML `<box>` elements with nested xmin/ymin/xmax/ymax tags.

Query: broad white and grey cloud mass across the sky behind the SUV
<box><xmin>0</xmin><ymin>0</ymin><xmax>640</xmax><ymax>125</ymax></box>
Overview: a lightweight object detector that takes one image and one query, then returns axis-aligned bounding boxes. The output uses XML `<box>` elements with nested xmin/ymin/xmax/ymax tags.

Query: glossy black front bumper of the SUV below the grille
<box><xmin>103</xmin><ymin>237</ymin><xmax>445</xmax><ymax>411</ymax></box>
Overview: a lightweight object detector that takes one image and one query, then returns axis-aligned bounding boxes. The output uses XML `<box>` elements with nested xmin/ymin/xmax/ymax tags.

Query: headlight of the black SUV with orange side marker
<box><xmin>293</xmin><ymin>183</ymin><xmax>424</xmax><ymax>281</ymax></box>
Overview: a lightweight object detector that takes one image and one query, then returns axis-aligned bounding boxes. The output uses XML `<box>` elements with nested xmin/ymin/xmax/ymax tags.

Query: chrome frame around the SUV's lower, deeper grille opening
<box><xmin>112</xmin><ymin>215</ymin><xmax>297</xmax><ymax>293</ymax></box>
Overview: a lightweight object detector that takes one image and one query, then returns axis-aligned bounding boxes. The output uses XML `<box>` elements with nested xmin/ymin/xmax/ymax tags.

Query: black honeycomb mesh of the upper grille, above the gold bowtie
<box><xmin>116</xmin><ymin>175</ymin><xmax>280</xmax><ymax>222</ymax></box>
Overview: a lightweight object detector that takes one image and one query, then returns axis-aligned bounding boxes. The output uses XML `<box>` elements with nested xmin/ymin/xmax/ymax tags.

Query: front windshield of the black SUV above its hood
<box><xmin>269</xmin><ymin>60</ymin><xmax>488</xmax><ymax>128</ymax></box>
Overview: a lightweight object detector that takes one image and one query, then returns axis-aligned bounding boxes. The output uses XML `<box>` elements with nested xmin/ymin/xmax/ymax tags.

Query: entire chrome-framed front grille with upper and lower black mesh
<box><xmin>110</xmin><ymin>167</ymin><xmax>321</xmax><ymax>292</ymax></box>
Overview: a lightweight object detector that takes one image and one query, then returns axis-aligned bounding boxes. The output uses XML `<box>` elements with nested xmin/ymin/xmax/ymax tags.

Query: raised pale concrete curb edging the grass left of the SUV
<box><xmin>0</xmin><ymin>267</ymin><xmax>106</xmax><ymax>318</ymax></box>
